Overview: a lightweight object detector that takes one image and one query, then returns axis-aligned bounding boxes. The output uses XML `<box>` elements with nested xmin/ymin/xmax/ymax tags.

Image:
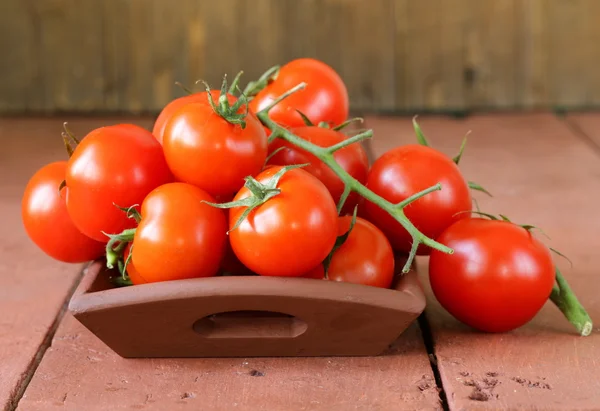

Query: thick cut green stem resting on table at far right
<box><xmin>550</xmin><ymin>267</ymin><xmax>593</xmax><ymax>337</ymax></box>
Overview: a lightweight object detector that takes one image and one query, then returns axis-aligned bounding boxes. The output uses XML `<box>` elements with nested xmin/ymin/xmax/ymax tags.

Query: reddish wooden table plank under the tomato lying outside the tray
<box><xmin>368</xmin><ymin>114</ymin><xmax>600</xmax><ymax>410</ymax></box>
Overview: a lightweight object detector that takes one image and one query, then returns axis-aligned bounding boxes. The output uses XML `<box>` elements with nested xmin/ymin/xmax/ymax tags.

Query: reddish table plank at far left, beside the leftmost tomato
<box><xmin>0</xmin><ymin>118</ymin><xmax>145</xmax><ymax>410</ymax></box>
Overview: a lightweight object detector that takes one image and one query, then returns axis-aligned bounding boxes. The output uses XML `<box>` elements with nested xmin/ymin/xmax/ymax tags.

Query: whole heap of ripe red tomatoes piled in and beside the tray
<box><xmin>22</xmin><ymin>59</ymin><xmax>576</xmax><ymax>331</ymax></box>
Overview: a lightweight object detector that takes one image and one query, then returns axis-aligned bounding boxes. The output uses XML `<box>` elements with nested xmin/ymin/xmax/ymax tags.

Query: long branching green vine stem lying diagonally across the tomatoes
<box><xmin>257</xmin><ymin>83</ymin><xmax>454</xmax><ymax>273</ymax></box>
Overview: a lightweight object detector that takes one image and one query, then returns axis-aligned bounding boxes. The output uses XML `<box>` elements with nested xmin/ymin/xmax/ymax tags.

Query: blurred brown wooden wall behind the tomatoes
<box><xmin>0</xmin><ymin>0</ymin><xmax>600</xmax><ymax>113</ymax></box>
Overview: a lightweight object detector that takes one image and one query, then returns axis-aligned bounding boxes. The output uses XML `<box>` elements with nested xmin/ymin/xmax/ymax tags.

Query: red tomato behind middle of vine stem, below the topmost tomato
<box><xmin>268</xmin><ymin>126</ymin><xmax>369</xmax><ymax>212</ymax></box>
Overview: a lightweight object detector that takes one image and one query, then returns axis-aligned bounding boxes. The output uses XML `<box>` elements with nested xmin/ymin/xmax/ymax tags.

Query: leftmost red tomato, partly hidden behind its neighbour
<box><xmin>21</xmin><ymin>161</ymin><xmax>105</xmax><ymax>263</ymax></box>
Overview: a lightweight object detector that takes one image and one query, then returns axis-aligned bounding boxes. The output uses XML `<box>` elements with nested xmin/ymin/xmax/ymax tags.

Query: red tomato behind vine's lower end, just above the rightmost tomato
<box><xmin>361</xmin><ymin>144</ymin><xmax>472</xmax><ymax>255</ymax></box>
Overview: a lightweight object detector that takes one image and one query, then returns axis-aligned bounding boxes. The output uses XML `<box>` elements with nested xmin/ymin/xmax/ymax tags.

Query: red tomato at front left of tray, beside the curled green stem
<box><xmin>131</xmin><ymin>183</ymin><xmax>227</xmax><ymax>283</ymax></box>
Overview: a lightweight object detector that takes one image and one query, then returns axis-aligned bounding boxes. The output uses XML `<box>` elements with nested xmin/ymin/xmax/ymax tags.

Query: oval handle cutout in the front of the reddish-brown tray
<box><xmin>193</xmin><ymin>311</ymin><xmax>308</xmax><ymax>338</ymax></box>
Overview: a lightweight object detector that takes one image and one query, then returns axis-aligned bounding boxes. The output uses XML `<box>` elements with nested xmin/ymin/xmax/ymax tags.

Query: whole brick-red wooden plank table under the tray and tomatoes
<box><xmin>0</xmin><ymin>113</ymin><xmax>600</xmax><ymax>411</ymax></box>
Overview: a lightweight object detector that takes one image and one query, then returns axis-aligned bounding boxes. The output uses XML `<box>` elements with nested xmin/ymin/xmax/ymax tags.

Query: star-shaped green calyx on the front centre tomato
<box><xmin>202</xmin><ymin>164</ymin><xmax>308</xmax><ymax>234</ymax></box>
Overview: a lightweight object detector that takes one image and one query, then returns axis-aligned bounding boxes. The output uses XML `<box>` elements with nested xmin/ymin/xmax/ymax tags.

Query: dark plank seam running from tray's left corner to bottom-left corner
<box><xmin>4</xmin><ymin>263</ymin><xmax>89</xmax><ymax>411</ymax></box>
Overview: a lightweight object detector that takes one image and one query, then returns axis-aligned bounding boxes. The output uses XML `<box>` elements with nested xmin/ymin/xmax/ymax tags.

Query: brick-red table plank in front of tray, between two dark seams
<box><xmin>9</xmin><ymin>119</ymin><xmax>441</xmax><ymax>411</ymax></box>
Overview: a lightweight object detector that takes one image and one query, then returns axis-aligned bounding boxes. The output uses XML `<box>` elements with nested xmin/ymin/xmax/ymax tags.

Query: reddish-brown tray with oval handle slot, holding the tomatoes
<box><xmin>69</xmin><ymin>261</ymin><xmax>425</xmax><ymax>358</ymax></box>
